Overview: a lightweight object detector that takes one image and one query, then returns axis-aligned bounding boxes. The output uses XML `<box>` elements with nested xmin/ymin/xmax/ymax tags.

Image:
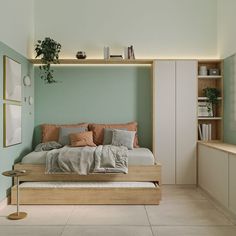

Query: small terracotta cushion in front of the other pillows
<box><xmin>69</xmin><ymin>131</ymin><xmax>96</xmax><ymax>147</ymax></box>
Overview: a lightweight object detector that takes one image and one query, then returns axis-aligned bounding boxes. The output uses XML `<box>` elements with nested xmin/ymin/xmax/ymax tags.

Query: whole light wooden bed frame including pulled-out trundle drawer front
<box><xmin>11</xmin><ymin>163</ymin><xmax>161</xmax><ymax>204</ymax></box>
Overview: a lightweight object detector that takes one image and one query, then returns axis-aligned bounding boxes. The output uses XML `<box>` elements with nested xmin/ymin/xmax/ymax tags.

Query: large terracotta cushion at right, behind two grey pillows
<box><xmin>89</xmin><ymin>122</ymin><xmax>139</xmax><ymax>148</ymax></box>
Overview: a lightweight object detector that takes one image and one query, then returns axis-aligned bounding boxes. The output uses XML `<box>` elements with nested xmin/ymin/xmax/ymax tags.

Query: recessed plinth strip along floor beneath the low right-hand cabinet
<box><xmin>198</xmin><ymin>186</ymin><xmax>236</xmax><ymax>224</ymax></box>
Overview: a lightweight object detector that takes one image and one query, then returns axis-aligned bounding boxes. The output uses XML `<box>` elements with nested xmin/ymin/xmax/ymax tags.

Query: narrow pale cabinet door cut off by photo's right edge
<box><xmin>229</xmin><ymin>154</ymin><xmax>236</xmax><ymax>215</ymax></box>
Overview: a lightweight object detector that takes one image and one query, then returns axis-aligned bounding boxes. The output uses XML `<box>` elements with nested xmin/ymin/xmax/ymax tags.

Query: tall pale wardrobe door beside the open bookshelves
<box><xmin>176</xmin><ymin>60</ymin><xmax>197</xmax><ymax>184</ymax></box>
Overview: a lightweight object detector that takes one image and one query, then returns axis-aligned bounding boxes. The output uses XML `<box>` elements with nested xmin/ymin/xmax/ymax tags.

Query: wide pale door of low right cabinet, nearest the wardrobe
<box><xmin>198</xmin><ymin>145</ymin><xmax>228</xmax><ymax>207</ymax></box>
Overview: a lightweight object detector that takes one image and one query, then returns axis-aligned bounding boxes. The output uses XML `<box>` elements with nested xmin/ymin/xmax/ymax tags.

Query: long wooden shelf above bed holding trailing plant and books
<box><xmin>29</xmin><ymin>59</ymin><xmax>153</xmax><ymax>65</ymax></box>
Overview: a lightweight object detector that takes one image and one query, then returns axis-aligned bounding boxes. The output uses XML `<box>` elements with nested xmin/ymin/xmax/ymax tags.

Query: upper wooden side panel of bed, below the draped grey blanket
<box><xmin>14</xmin><ymin>163</ymin><xmax>161</xmax><ymax>182</ymax></box>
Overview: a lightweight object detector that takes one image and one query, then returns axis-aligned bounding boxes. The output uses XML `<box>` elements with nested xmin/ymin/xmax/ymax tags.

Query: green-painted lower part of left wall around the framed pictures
<box><xmin>0</xmin><ymin>42</ymin><xmax>34</xmax><ymax>201</ymax></box>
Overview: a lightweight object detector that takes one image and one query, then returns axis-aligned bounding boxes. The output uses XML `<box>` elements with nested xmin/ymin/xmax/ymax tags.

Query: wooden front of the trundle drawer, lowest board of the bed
<box><xmin>11</xmin><ymin>186</ymin><xmax>161</xmax><ymax>204</ymax></box>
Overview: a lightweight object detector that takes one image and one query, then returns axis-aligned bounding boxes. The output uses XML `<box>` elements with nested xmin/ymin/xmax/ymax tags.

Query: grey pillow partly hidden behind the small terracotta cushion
<box><xmin>58</xmin><ymin>127</ymin><xmax>88</xmax><ymax>145</ymax></box>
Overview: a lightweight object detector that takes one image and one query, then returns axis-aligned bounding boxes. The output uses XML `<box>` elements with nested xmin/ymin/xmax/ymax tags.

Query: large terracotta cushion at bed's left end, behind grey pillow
<box><xmin>41</xmin><ymin>123</ymin><xmax>88</xmax><ymax>143</ymax></box>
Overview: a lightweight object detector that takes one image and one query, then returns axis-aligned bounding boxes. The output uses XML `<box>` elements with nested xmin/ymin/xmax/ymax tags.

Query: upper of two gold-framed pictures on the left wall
<box><xmin>3</xmin><ymin>56</ymin><xmax>21</xmax><ymax>102</ymax></box>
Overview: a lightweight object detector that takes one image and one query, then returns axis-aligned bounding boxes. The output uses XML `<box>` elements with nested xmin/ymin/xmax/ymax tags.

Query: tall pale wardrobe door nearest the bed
<box><xmin>153</xmin><ymin>60</ymin><xmax>175</xmax><ymax>184</ymax></box>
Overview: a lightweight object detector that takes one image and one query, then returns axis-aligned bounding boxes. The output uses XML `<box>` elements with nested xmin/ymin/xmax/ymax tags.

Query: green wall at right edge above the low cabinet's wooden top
<box><xmin>224</xmin><ymin>55</ymin><xmax>236</xmax><ymax>144</ymax></box>
